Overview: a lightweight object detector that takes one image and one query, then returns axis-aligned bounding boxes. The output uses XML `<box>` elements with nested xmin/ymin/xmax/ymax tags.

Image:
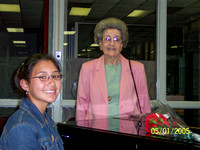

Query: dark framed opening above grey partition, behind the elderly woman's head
<box><xmin>77</xmin><ymin>23</ymin><xmax>156</xmax><ymax>61</ymax></box>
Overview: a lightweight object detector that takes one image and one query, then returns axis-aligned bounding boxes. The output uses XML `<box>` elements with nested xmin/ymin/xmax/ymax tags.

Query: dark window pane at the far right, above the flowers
<box><xmin>167</xmin><ymin>0</ymin><xmax>200</xmax><ymax>101</ymax></box>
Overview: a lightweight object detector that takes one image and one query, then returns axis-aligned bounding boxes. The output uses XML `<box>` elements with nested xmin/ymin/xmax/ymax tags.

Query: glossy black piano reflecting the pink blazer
<box><xmin>57</xmin><ymin>118</ymin><xmax>200</xmax><ymax>150</ymax></box>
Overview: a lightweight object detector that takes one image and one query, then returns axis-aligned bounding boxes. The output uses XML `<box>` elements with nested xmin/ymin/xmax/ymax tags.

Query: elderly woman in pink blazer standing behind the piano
<box><xmin>76</xmin><ymin>18</ymin><xmax>151</xmax><ymax>120</ymax></box>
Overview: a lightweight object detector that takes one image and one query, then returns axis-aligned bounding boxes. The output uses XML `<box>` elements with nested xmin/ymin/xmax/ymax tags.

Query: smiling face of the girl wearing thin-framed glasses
<box><xmin>20</xmin><ymin>60</ymin><xmax>61</xmax><ymax>109</ymax></box>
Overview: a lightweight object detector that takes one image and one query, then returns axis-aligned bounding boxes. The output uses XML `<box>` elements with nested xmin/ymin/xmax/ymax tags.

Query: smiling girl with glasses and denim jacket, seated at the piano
<box><xmin>0</xmin><ymin>54</ymin><xmax>64</xmax><ymax>150</ymax></box>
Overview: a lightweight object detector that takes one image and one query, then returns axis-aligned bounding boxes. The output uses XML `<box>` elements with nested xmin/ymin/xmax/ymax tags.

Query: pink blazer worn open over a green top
<box><xmin>76</xmin><ymin>54</ymin><xmax>151</xmax><ymax>120</ymax></box>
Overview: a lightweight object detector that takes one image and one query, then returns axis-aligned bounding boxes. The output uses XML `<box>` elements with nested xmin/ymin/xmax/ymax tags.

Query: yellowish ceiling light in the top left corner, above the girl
<box><xmin>0</xmin><ymin>4</ymin><xmax>20</xmax><ymax>12</ymax></box>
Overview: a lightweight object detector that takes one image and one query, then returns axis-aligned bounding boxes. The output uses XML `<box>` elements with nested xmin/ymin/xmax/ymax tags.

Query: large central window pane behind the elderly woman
<box><xmin>63</xmin><ymin>0</ymin><xmax>156</xmax><ymax>99</ymax></box>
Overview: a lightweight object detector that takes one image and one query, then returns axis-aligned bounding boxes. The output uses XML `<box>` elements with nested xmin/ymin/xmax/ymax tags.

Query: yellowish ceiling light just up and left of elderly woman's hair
<box><xmin>69</xmin><ymin>7</ymin><xmax>91</xmax><ymax>16</ymax></box>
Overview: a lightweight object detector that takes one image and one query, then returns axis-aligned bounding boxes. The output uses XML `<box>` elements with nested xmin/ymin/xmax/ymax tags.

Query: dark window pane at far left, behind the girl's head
<box><xmin>0</xmin><ymin>0</ymin><xmax>44</xmax><ymax>99</ymax></box>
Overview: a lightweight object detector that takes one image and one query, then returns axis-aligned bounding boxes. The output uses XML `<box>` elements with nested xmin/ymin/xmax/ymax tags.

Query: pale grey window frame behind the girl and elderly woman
<box><xmin>0</xmin><ymin>0</ymin><xmax>200</xmax><ymax>122</ymax></box>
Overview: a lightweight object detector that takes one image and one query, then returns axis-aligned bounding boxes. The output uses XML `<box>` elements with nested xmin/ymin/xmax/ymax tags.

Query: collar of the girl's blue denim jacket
<box><xmin>20</xmin><ymin>97</ymin><xmax>50</xmax><ymax>128</ymax></box>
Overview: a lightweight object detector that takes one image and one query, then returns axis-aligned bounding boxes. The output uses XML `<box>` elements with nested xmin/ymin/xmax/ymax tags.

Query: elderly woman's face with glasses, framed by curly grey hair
<box><xmin>100</xmin><ymin>29</ymin><xmax>123</xmax><ymax>57</ymax></box>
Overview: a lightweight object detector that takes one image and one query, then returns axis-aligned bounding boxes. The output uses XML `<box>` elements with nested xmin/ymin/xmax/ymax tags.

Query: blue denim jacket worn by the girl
<box><xmin>0</xmin><ymin>98</ymin><xmax>64</xmax><ymax>150</ymax></box>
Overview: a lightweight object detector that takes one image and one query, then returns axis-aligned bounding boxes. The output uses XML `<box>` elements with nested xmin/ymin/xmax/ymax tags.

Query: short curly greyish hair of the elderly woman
<box><xmin>94</xmin><ymin>18</ymin><xmax>128</xmax><ymax>48</ymax></box>
